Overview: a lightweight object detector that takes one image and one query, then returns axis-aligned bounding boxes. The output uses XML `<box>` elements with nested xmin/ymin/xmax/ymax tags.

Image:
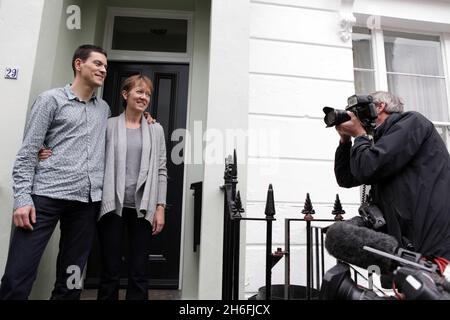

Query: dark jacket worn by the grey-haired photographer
<box><xmin>334</xmin><ymin>112</ymin><xmax>450</xmax><ymax>259</ymax></box>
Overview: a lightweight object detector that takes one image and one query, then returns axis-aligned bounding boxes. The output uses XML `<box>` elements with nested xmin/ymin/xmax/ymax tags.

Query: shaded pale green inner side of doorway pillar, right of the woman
<box><xmin>180</xmin><ymin>0</ymin><xmax>211</xmax><ymax>300</ymax></box>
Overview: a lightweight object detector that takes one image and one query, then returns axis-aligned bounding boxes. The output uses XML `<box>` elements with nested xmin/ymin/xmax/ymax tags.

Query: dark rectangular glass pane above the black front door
<box><xmin>112</xmin><ymin>17</ymin><xmax>187</xmax><ymax>52</ymax></box>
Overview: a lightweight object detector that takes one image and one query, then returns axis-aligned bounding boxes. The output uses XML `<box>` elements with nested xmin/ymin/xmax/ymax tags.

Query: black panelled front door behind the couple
<box><xmin>85</xmin><ymin>62</ymin><xmax>189</xmax><ymax>289</ymax></box>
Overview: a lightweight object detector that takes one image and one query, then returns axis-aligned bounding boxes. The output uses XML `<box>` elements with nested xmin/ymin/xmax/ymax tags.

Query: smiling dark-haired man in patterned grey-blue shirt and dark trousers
<box><xmin>0</xmin><ymin>45</ymin><xmax>110</xmax><ymax>300</ymax></box>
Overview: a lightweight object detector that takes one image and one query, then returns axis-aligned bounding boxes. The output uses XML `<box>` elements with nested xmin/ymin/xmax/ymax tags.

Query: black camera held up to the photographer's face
<box><xmin>323</xmin><ymin>95</ymin><xmax>378</xmax><ymax>132</ymax></box>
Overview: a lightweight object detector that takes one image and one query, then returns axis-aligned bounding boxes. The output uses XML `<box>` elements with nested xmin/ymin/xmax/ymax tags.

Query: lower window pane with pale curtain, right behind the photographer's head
<box><xmin>388</xmin><ymin>74</ymin><xmax>449</xmax><ymax>121</ymax></box>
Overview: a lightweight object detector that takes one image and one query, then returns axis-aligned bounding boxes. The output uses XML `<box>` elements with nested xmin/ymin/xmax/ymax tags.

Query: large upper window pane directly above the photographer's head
<box><xmin>384</xmin><ymin>31</ymin><xmax>444</xmax><ymax>76</ymax></box>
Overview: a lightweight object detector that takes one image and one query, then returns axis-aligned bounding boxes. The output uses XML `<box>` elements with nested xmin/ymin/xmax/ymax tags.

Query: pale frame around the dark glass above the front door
<box><xmin>103</xmin><ymin>7</ymin><xmax>193</xmax><ymax>64</ymax></box>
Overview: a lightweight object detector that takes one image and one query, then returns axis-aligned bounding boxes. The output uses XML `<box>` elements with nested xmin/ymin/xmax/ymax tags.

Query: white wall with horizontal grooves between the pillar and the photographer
<box><xmin>245</xmin><ymin>0</ymin><xmax>359</xmax><ymax>296</ymax></box>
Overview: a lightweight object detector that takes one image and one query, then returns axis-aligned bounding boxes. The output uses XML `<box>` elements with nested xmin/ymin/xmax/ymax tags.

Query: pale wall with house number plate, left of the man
<box><xmin>0</xmin><ymin>0</ymin><xmax>44</xmax><ymax>282</ymax></box>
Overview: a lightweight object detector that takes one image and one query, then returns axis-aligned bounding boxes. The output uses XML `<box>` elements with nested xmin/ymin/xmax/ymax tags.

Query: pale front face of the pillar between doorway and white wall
<box><xmin>198</xmin><ymin>0</ymin><xmax>250</xmax><ymax>299</ymax></box>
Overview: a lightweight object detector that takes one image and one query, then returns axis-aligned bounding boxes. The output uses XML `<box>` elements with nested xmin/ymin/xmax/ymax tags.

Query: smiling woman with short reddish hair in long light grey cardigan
<box><xmin>97</xmin><ymin>75</ymin><xmax>167</xmax><ymax>300</ymax></box>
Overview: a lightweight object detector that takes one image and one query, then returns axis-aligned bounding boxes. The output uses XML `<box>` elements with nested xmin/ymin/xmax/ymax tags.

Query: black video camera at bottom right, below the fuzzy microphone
<box><xmin>319</xmin><ymin>247</ymin><xmax>450</xmax><ymax>300</ymax></box>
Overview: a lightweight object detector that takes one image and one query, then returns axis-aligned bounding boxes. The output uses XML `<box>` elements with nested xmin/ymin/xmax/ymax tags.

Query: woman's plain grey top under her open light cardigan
<box><xmin>123</xmin><ymin>128</ymin><xmax>142</xmax><ymax>208</ymax></box>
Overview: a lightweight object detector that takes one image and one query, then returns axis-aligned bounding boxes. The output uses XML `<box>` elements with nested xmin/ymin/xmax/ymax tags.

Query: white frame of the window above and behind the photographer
<box><xmin>357</xmin><ymin>24</ymin><xmax>450</xmax><ymax>150</ymax></box>
